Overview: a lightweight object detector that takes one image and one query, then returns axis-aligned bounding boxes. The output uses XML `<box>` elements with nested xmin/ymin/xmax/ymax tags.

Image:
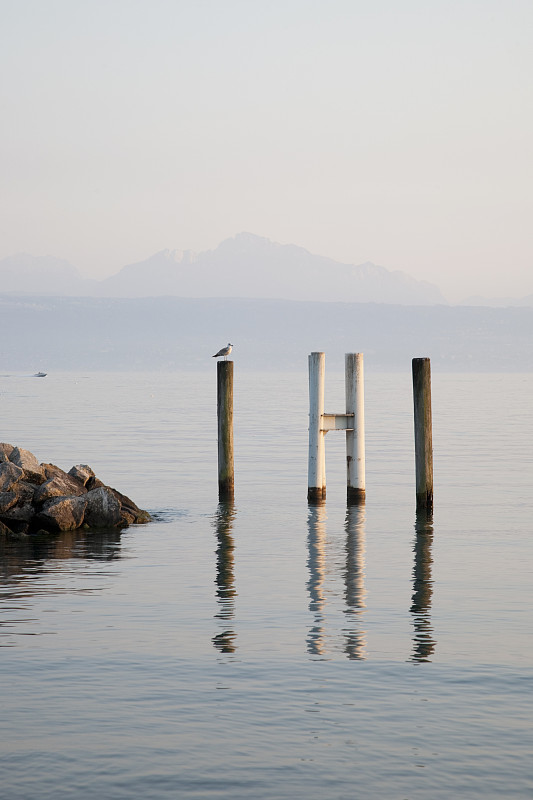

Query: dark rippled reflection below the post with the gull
<box><xmin>213</xmin><ymin>500</ymin><xmax>237</xmax><ymax>653</ymax></box>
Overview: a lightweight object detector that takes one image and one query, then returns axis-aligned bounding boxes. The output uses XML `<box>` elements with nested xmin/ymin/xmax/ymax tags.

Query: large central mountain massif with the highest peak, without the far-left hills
<box><xmin>98</xmin><ymin>233</ymin><xmax>446</xmax><ymax>305</ymax></box>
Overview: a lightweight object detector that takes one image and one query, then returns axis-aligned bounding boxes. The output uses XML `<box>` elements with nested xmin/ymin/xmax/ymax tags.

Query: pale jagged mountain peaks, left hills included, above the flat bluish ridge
<box><xmin>0</xmin><ymin>233</ymin><xmax>446</xmax><ymax>305</ymax></box>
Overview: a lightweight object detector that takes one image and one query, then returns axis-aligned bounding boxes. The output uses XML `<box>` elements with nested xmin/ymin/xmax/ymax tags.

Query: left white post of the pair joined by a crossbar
<box><xmin>307</xmin><ymin>353</ymin><xmax>326</xmax><ymax>503</ymax></box>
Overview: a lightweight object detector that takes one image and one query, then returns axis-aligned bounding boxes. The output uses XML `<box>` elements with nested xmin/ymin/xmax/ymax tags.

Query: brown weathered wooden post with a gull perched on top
<box><xmin>217</xmin><ymin>361</ymin><xmax>235</xmax><ymax>500</ymax></box>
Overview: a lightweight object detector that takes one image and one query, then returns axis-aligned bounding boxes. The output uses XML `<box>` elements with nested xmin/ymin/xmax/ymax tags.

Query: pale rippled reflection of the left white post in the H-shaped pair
<box><xmin>307</xmin><ymin>503</ymin><xmax>327</xmax><ymax>655</ymax></box>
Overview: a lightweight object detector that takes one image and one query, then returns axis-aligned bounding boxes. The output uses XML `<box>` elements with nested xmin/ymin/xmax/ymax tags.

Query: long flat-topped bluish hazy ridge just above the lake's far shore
<box><xmin>0</xmin><ymin>295</ymin><xmax>533</xmax><ymax>374</ymax></box>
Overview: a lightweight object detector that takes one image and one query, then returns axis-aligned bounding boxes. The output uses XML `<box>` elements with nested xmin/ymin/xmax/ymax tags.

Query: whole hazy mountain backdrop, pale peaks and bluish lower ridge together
<box><xmin>0</xmin><ymin>234</ymin><xmax>533</xmax><ymax>377</ymax></box>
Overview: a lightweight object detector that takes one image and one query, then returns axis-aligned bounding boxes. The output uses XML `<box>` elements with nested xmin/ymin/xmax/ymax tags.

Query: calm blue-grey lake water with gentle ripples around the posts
<box><xmin>0</xmin><ymin>372</ymin><xmax>533</xmax><ymax>800</ymax></box>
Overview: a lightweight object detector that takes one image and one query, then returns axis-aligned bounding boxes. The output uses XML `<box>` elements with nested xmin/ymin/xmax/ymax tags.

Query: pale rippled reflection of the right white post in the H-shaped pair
<box><xmin>344</xmin><ymin>505</ymin><xmax>366</xmax><ymax>660</ymax></box>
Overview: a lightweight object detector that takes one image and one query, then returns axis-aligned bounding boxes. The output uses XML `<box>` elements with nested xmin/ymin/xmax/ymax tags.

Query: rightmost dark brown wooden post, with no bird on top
<box><xmin>413</xmin><ymin>358</ymin><xmax>433</xmax><ymax>512</ymax></box>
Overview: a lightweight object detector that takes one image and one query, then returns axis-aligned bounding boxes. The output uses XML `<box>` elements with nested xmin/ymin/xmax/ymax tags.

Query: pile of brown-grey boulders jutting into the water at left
<box><xmin>0</xmin><ymin>443</ymin><xmax>150</xmax><ymax>538</ymax></box>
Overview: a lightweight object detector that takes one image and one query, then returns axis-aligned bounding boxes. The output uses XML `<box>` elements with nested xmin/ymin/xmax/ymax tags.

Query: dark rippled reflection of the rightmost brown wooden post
<box><xmin>410</xmin><ymin>511</ymin><xmax>436</xmax><ymax>662</ymax></box>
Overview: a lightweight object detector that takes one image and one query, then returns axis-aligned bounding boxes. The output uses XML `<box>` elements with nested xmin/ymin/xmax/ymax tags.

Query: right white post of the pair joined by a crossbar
<box><xmin>345</xmin><ymin>353</ymin><xmax>365</xmax><ymax>505</ymax></box>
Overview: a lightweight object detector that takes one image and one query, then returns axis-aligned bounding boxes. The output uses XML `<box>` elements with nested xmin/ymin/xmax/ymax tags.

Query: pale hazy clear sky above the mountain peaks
<box><xmin>0</xmin><ymin>0</ymin><xmax>533</xmax><ymax>301</ymax></box>
